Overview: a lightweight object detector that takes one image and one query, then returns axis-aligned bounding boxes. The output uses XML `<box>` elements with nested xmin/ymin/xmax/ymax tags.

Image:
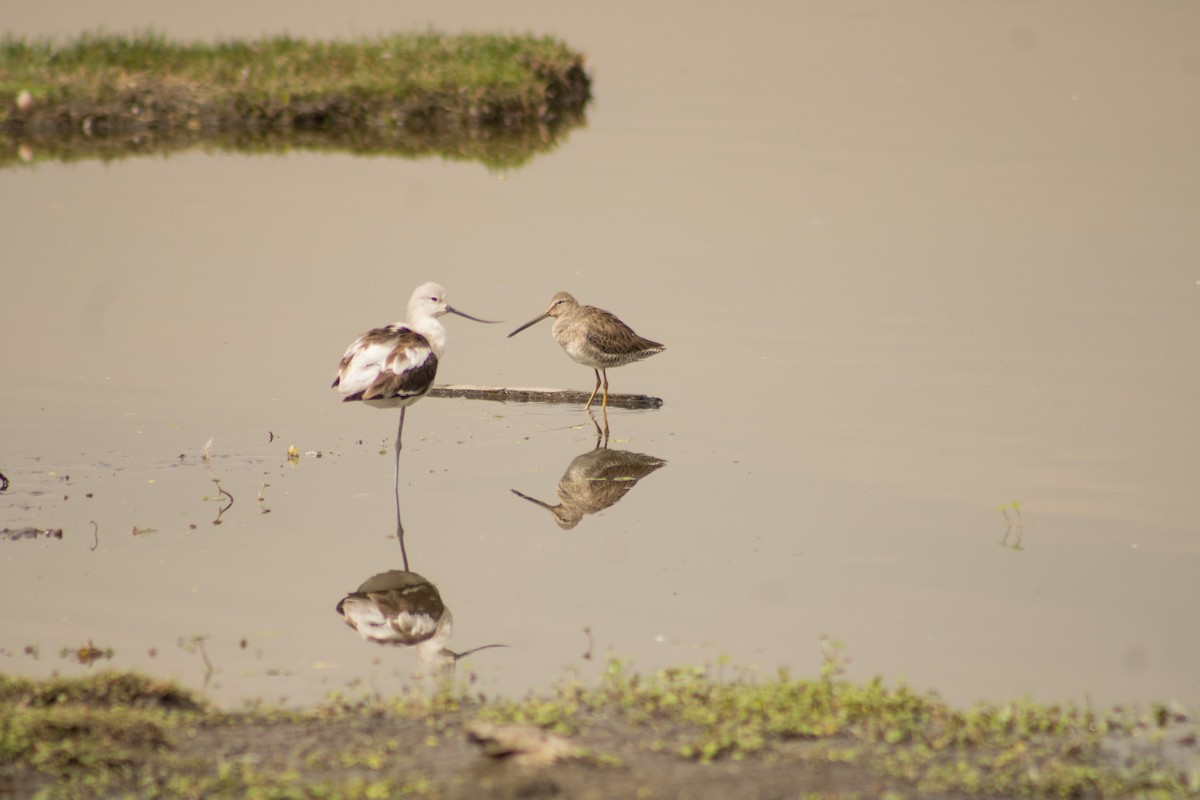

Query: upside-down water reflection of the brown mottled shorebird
<box><xmin>512</xmin><ymin>443</ymin><xmax>666</xmax><ymax>530</ymax></box>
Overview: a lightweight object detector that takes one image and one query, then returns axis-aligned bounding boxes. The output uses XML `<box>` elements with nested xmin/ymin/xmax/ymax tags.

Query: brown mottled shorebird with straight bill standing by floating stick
<box><xmin>509</xmin><ymin>291</ymin><xmax>666</xmax><ymax>410</ymax></box>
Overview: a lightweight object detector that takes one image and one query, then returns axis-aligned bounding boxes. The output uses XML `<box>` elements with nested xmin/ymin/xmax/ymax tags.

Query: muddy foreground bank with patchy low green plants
<box><xmin>0</xmin><ymin>662</ymin><xmax>1200</xmax><ymax>799</ymax></box>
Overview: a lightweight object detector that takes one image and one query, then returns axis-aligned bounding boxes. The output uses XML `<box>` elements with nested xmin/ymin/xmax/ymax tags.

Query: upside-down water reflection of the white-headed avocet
<box><xmin>337</xmin><ymin>570</ymin><xmax>505</xmax><ymax>673</ymax></box>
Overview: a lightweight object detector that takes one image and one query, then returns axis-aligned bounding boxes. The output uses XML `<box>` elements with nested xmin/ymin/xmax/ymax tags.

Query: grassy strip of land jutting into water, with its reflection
<box><xmin>0</xmin><ymin>32</ymin><xmax>590</xmax><ymax>166</ymax></box>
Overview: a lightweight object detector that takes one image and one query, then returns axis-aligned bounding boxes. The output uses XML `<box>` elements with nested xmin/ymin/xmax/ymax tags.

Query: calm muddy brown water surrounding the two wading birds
<box><xmin>0</xmin><ymin>1</ymin><xmax>1200</xmax><ymax>706</ymax></box>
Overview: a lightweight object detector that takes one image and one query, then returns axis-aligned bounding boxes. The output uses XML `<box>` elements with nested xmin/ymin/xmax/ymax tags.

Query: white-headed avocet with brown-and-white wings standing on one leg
<box><xmin>334</xmin><ymin>283</ymin><xmax>494</xmax><ymax>492</ymax></box>
